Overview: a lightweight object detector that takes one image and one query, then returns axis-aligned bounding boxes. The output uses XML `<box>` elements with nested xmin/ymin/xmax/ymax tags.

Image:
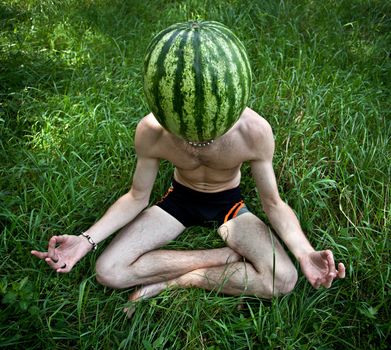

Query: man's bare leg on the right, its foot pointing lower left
<box><xmin>131</xmin><ymin>213</ymin><xmax>297</xmax><ymax>300</ymax></box>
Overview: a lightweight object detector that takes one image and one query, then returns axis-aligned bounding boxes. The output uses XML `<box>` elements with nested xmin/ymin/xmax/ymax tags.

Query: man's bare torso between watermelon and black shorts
<box><xmin>136</xmin><ymin>108</ymin><xmax>270</xmax><ymax>192</ymax></box>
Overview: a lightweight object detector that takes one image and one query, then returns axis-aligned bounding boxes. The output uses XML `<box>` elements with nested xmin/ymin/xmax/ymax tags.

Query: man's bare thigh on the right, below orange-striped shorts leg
<box><xmin>218</xmin><ymin>212</ymin><xmax>293</xmax><ymax>273</ymax></box>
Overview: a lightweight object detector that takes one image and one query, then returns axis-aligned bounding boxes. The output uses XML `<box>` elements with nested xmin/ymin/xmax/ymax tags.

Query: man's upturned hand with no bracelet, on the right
<box><xmin>300</xmin><ymin>250</ymin><xmax>345</xmax><ymax>289</ymax></box>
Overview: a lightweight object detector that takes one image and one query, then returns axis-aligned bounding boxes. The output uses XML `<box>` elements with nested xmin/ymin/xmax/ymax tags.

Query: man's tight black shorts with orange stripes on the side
<box><xmin>156</xmin><ymin>180</ymin><xmax>248</xmax><ymax>227</ymax></box>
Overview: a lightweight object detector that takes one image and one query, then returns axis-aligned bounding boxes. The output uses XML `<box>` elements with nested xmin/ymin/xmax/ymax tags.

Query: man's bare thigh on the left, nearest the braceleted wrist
<box><xmin>99</xmin><ymin>206</ymin><xmax>185</xmax><ymax>266</ymax></box>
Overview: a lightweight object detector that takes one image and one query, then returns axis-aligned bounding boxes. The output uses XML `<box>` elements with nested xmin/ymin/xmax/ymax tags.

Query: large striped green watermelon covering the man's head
<box><xmin>144</xmin><ymin>21</ymin><xmax>251</xmax><ymax>142</ymax></box>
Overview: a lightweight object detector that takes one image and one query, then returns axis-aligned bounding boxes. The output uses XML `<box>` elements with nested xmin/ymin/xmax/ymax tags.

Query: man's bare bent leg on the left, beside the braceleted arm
<box><xmin>96</xmin><ymin>206</ymin><xmax>240</xmax><ymax>288</ymax></box>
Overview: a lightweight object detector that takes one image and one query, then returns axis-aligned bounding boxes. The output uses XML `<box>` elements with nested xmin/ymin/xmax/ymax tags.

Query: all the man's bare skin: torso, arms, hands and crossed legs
<box><xmin>32</xmin><ymin>108</ymin><xmax>345</xmax><ymax>314</ymax></box>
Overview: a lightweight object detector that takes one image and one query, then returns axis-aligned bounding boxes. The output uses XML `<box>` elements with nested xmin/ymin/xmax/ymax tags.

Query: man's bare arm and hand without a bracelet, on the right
<box><xmin>251</xmin><ymin>117</ymin><xmax>345</xmax><ymax>288</ymax></box>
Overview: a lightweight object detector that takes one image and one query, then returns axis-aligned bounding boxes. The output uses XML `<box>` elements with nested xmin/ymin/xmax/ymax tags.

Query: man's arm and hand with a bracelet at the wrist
<box><xmin>31</xmin><ymin>116</ymin><xmax>159</xmax><ymax>272</ymax></box>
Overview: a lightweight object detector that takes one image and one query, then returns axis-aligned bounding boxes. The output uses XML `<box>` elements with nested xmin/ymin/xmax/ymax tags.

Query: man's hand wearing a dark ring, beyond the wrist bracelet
<box><xmin>31</xmin><ymin>235</ymin><xmax>92</xmax><ymax>273</ymax></box>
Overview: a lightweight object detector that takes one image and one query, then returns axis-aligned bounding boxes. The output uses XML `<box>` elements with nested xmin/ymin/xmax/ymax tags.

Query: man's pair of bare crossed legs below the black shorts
<box><xmin>96</xmin><ymin>206</ymin><xmax>297</xmax><ymax>300</ymax></box>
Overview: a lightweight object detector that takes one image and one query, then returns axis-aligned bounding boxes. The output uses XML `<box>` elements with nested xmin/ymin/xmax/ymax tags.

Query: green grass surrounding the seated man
<box><xmin>0</xmin><ymin>0</ymin><xmax>391</xmax><ymax>350</ymax></box>
